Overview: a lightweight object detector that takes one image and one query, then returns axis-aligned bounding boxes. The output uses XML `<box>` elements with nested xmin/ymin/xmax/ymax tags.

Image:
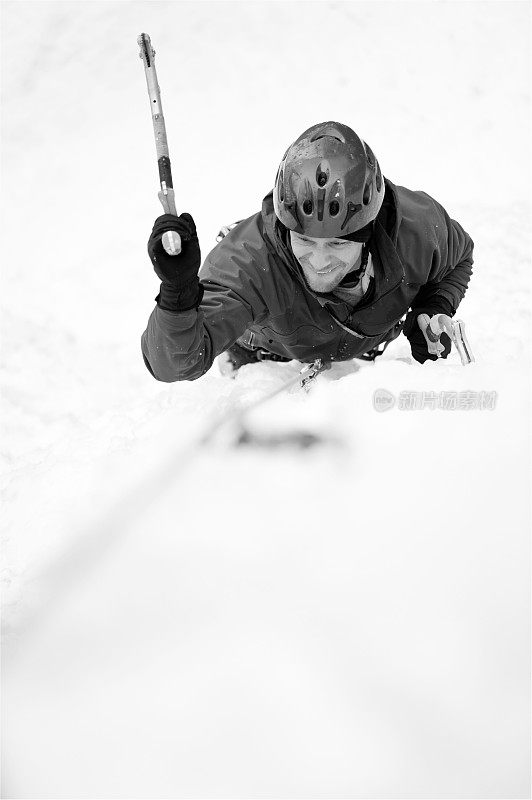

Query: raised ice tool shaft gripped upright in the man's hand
<box><xmin>137</xmin><ymin>33</ymin><xmax>181</xmax><ymax>256</ymax></box>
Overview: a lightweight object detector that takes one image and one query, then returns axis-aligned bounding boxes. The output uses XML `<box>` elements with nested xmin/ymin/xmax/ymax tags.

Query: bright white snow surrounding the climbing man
<box><xmin>1</xmin><ymin>2</ymin><xmax>531</xmax><ymax>798</ymax></box>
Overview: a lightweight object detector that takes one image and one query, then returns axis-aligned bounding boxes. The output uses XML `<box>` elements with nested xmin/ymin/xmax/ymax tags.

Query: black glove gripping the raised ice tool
<box><xmin>148</xmin><ymin>214</ymin><xmax>203</xmax><ymax>311</ymax></box>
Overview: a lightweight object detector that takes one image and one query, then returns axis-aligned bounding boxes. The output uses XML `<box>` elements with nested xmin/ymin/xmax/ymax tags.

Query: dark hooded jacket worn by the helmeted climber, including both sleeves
<box><xmin>142</xmin><ymin>180</ymin><xmax>473</xmax><ymax>381</ymax></box>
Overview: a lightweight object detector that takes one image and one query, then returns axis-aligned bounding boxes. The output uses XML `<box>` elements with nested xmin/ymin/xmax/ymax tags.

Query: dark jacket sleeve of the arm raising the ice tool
<box><xmin>141</xmin><ymin>218</ymin><xmax>267</xmax><ymax>382</ymax></box>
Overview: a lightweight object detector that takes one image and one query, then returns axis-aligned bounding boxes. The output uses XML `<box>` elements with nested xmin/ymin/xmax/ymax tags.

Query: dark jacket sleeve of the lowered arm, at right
<box><xmin>412</xmin><ymin>195</ymin><xmax>473</xmax><ymax>314</ymax></box>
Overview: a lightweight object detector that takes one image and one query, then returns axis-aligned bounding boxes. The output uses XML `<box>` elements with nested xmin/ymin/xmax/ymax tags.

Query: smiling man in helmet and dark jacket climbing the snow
<box><xmin>142</xmin><ymin>122</ymin><xmax>473</xmax><ymax>381</ymax></box>
